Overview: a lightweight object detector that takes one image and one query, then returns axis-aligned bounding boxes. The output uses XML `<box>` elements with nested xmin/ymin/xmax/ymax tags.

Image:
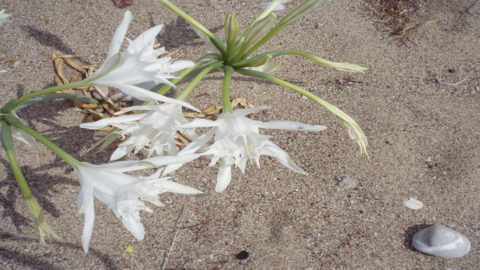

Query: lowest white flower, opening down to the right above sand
<box><xmin>75</xmin><ymin>155</ymin><xmax>201</xmax><ymax>252</ymax></box>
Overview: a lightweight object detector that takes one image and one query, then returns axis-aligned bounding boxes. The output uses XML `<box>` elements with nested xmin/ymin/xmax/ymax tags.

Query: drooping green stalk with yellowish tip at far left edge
<box><xmin>1</xmin><ymin>122</ymin><xmax>59</xmax><ymax>244</ymax></box>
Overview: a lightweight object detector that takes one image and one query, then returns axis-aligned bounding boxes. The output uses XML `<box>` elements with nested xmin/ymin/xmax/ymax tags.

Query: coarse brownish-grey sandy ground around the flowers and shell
<box><xmin>0</xmin><ymin>0</ymin><xmax>480</xmax><ymax>269</ymax></box>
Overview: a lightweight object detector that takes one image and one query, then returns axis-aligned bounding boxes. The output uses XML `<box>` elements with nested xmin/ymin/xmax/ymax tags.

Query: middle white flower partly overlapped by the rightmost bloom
<box><xmin>80</xmin><ymin>103</ymin><xmax>198</xmax><ymax>161</ymax></box>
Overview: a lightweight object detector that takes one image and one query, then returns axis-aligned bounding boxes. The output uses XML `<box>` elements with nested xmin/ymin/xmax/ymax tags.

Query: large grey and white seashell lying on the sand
<box><xmin>412</xmin><ymin>225</ymin><xmax>471</xmax><ymax>259</ymax></box>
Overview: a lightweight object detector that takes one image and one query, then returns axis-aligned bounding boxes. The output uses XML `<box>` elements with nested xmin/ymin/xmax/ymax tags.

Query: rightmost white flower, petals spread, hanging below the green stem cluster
<box><xmin>164</xmin><ymin>106</ymin><xmax>326</xmax><ymax>192</ymax></box>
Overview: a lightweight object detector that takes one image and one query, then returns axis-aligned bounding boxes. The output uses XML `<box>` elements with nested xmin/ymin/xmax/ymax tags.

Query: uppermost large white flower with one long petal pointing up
<box><xmin>87</xmin><ymin>11</ymin><xmax>196</xmax><ymax>110</ymax></box>
